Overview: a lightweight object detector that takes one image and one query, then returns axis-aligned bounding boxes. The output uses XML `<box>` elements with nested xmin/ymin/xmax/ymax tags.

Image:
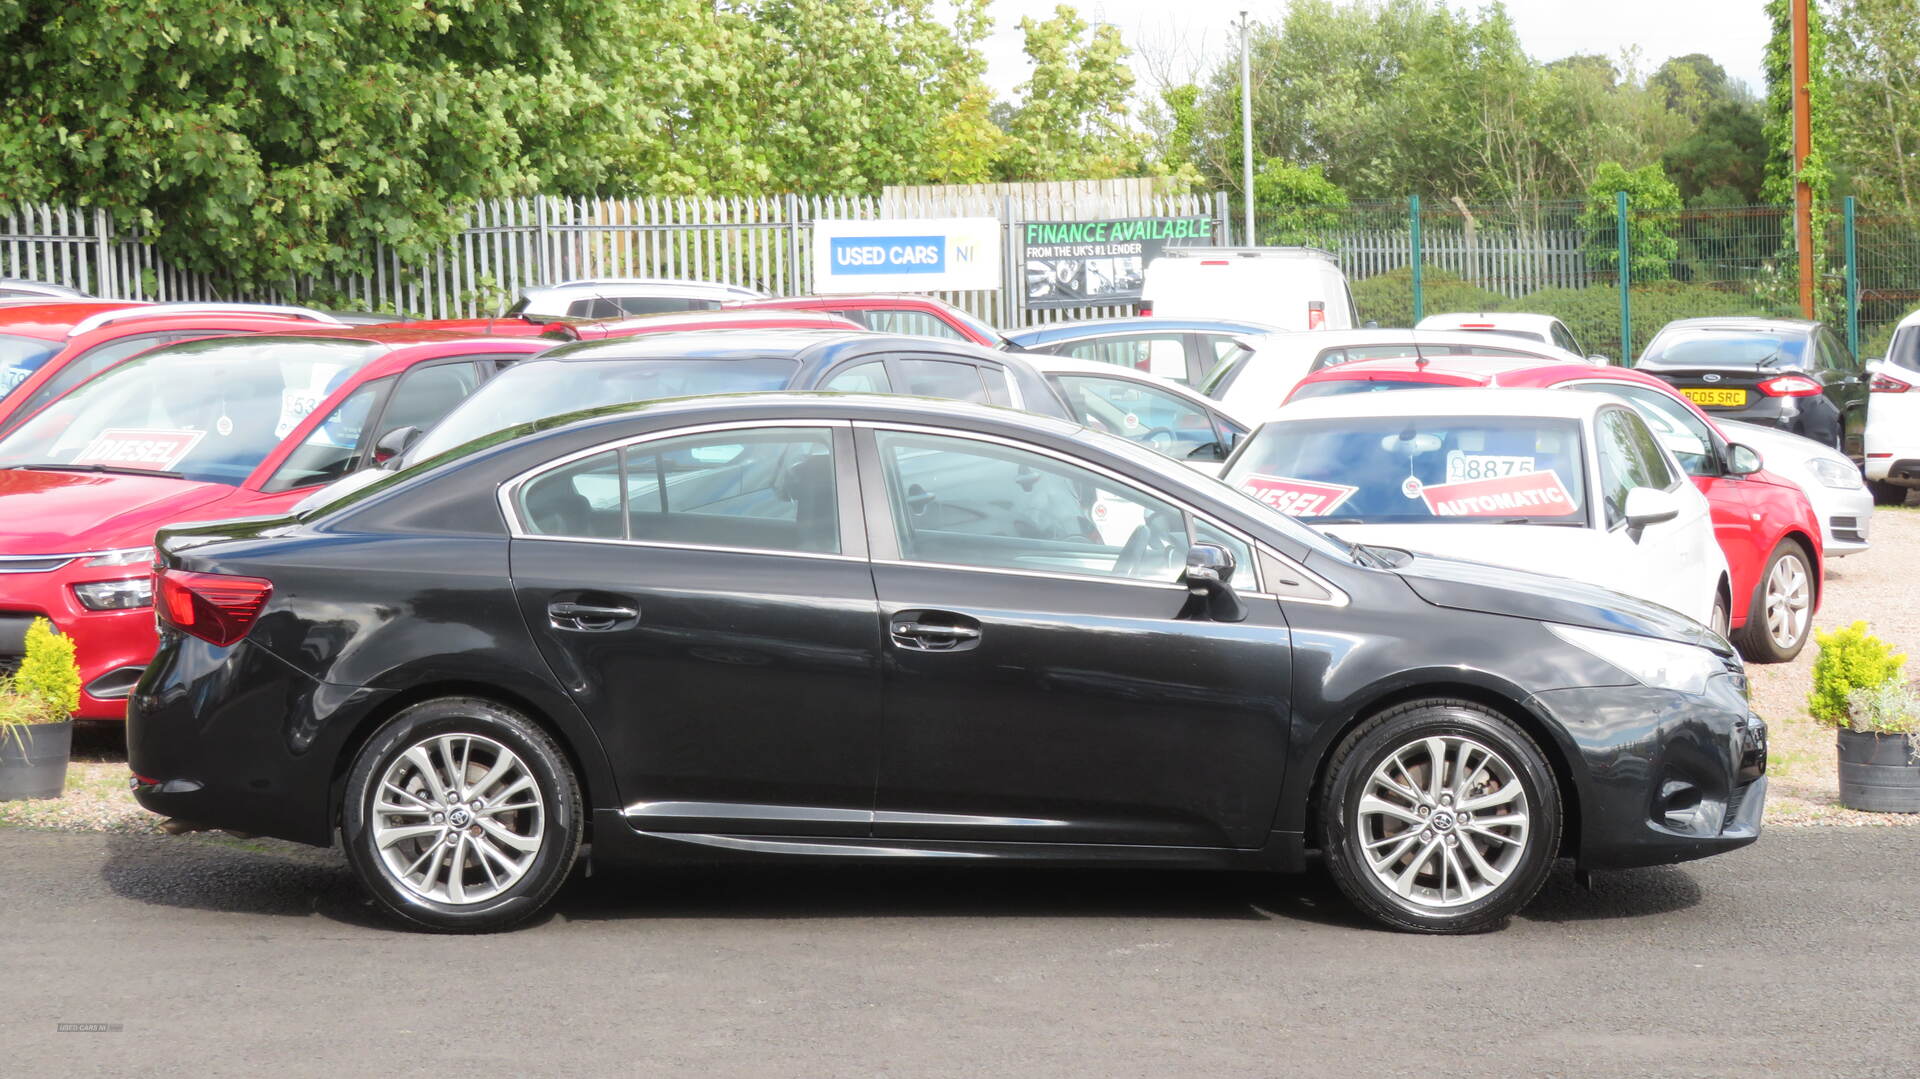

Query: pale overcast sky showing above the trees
<box><xmin>985</xmin><ymin>0</ymin><xmax>1768</xmax><ymax>98</ymax></box>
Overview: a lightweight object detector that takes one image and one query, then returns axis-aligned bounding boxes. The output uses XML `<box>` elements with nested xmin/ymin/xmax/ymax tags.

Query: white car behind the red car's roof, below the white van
<box><xmin>1200</xmin><ymin>330</ymin><xmax>1592</xmax><ymax>417</ymax></box>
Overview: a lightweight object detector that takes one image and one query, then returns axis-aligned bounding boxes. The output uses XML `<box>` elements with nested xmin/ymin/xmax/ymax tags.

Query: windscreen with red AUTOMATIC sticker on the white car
<box><xmin>1223</xmin><ymin>417</ymin><xmax>1586</xmax><ymax>524</ymax></box>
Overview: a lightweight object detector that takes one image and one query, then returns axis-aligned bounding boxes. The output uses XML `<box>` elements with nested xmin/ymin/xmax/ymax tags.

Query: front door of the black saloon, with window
<box><xmin>856</xmin><ymin>424</ymin><xmax>1290</xmax><ymax>847</ymax></box>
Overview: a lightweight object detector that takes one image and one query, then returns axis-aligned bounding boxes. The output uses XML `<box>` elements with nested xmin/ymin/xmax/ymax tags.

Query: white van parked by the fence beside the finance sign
<box><xmin>1140</xmin><ymin>248</ymin><xmax>1357</xmax><ymax>330</ymax></box>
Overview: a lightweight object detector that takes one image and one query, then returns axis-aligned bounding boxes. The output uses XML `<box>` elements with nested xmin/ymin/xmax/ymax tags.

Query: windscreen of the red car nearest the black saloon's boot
<box><xmin>0</xmin><ymin>338</ymin><xmax>386</xmax><ymax>484</ymax></box>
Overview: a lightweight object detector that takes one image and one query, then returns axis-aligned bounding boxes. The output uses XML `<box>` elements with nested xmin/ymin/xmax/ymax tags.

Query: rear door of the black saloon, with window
<box><xmin>503</xmin><ymin>420</ymin><xmax>879</xmax><ymax>835</ymax></box>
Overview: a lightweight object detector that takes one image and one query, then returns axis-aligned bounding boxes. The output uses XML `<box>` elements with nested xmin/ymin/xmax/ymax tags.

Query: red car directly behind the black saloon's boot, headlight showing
<box><xmin>0</xmin><ymin>326</ymin><xmax>553</xmax><ymax>720</ymax></box>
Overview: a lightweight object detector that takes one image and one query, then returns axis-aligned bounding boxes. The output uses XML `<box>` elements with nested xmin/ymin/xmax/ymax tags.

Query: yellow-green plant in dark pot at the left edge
<box><xmin>0</xmin><ymin>618</ymin><xmax>81</xmax><ymax>801</ymax></box>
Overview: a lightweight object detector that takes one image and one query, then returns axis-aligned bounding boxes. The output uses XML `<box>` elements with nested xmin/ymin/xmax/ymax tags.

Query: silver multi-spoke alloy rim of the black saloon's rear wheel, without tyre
<box><xmin>369</xmin><ymin>733</ymin><xmax>547</xmax><ymax>904</ymax></box>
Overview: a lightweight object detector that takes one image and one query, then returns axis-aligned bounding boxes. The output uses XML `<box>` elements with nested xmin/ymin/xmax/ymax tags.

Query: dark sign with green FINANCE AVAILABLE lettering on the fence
<box><xmin>1020</xmin><ymin>217</ymin><xmax>1213</xmax><ymax>307</ymax></box>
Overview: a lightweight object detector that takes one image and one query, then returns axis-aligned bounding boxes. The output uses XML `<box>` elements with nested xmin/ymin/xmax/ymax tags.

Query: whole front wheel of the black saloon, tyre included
<box><xmin>1317</xmin><ymin>701</ymin><xmax>1561</xmax><ymax>933</ymax></box>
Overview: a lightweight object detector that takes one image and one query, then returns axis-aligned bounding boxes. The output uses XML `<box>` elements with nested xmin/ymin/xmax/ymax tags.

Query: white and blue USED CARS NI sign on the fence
<box><xmin>814</xmin><ymin>217</ymin><xmax>1004</xmax><ymax>294</ymax></box>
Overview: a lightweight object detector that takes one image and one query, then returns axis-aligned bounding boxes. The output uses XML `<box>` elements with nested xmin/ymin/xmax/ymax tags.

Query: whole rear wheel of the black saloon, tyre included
<box><xmin>340</xmin><ymin>697</ymin><xmax>582</xmax><ymax>933</ymax></box>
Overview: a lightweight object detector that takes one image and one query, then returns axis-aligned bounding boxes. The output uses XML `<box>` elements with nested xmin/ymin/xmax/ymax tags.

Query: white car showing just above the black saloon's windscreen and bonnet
<box><xmin>1021</xmin><ymin>353</ymin><xmax>1252</xmax><ymax>476</ymax></box>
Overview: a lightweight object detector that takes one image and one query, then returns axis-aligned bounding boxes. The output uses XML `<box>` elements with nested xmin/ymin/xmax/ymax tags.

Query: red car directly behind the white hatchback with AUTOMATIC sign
<box><xmin>1286</xmin><ymin>357</ymin><xmax>1824</xmax><ymax>662</ymax></box>
